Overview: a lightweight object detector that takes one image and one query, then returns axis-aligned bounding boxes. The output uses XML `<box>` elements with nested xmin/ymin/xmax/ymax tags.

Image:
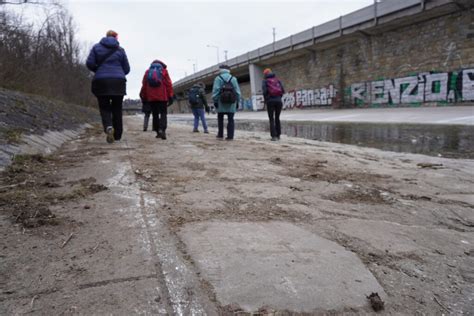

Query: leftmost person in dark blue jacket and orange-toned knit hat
<box><xmin>86</xmin><ymin>31</ymin><xmax>130</xmax><ymax>143</ymax></box>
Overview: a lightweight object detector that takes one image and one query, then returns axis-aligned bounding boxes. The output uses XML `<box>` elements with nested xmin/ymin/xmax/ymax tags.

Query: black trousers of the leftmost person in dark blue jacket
<box><xmin>97</xmin><ymin>95</ymin><xmax>123</xmax><ymax>140</ymax></box>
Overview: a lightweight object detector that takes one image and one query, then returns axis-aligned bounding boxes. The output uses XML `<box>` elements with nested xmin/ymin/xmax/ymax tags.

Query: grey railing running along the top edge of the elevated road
<box><xmin>174</xmin><ymin>0</ymin><xmax>427</xmax><ymax>87</ymax></box>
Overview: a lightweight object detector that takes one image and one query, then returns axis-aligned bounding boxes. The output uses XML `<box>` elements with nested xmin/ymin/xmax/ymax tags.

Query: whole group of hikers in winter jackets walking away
<box><xmin>86</xmin><ymin>30</ymin><xmax>285</xmax><ymax>143</ymax></box>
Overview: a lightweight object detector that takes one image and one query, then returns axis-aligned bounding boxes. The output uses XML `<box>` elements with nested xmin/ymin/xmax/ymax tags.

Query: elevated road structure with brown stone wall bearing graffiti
<box><xmin>171</xmin><ymin>0</ymin><xmax>474</xmax><ymax>113</ymax></box>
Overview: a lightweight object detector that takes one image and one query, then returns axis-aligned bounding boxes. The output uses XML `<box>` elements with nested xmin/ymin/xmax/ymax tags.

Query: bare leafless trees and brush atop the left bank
<box><xmin>0</xmin><ymin>6</ymin><xmax>93</xmax><ymax>104</ymax></box>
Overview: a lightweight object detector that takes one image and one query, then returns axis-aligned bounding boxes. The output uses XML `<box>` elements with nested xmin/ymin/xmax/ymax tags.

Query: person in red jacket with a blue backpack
<box><xmin>141</xmin><ymin>59</ymin><xmax>174</xmax><ymax>139</ymax></box>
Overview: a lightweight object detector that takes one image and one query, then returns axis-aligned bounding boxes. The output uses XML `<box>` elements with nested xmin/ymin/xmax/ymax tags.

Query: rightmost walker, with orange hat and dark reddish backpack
<box><xmin>262</xmin><ymin>68</ymin><xmax>285</xmax><ymax>141</ymax></box>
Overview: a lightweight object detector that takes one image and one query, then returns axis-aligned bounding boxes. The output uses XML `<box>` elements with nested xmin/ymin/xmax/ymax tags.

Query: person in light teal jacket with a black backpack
<box><xmin>212</xmin><ymin>65</ymin><xmax>241</xmax><ymax>140</ymax></box>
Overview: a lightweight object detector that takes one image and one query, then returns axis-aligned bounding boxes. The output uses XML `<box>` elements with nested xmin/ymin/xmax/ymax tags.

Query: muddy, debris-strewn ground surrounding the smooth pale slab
<box><xmin>0</xmin><ymin>117</ymin><xmax>474</xmax><ymax>315</ymax></box>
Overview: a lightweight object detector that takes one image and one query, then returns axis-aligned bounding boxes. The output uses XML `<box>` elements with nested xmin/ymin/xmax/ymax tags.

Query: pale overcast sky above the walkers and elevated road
<box><xmin>19</xmin><ymin>0</ymin><xmax>373</xmax><ymax>99</ymax></box>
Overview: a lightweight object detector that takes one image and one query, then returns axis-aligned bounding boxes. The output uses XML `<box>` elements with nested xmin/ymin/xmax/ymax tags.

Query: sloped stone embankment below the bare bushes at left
<box><xmin>0</xmin><ymin>88</ymin><xmax>99</xmax><ymax>168</ymax></box>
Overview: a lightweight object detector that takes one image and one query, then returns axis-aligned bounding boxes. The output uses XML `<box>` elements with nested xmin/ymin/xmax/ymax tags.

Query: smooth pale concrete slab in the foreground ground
<box><xmin>180</xmin><ymin>221</ymin><xmax>386</xmax><ymax>312</ymax></box>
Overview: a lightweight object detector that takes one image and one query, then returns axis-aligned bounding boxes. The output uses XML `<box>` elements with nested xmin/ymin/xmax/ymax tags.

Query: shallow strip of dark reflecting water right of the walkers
<box><xmin>172</xmin><ymin>119</ymin><xmax>474</xmax><ymax>159</ymax></box>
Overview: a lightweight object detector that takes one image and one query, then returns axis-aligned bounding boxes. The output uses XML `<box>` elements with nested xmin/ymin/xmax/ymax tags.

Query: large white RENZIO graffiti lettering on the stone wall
<box><xmin>350</xmin><ymin>69</ymin><xmax>474</xmax><ymax>105</ymax></box>
